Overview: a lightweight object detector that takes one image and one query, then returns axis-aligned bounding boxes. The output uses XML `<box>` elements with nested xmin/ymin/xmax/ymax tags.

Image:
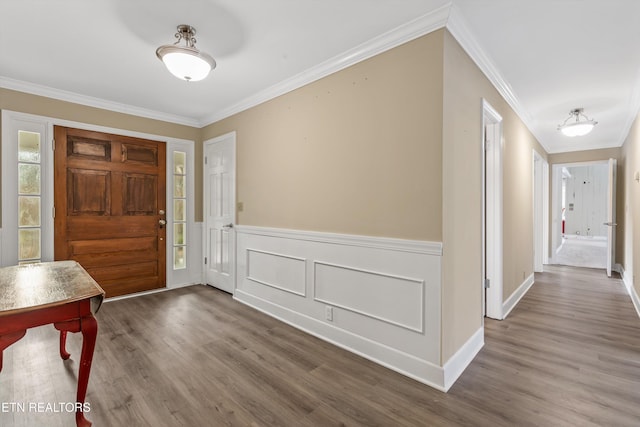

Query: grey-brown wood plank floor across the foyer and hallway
<box><xmin>0</xmin><ymin>266</ymin><xmax>640</xmax><ymax>427</ymax></box>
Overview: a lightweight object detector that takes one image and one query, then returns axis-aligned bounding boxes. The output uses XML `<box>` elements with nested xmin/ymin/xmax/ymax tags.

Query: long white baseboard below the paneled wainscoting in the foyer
<box><xmin>233</xmin><ymin>289</ymin><xmax>446</xmax><ymax>391</ymax></box>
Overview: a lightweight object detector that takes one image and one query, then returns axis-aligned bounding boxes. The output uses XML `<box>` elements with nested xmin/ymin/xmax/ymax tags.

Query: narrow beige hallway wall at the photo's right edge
<box><xmin>618</xmin><ymin>115</ymin><xmax>640</xmax><ymax>294</ymax></box>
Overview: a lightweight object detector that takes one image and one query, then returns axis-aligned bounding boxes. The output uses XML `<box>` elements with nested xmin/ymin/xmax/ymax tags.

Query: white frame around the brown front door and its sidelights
<box><xmin>0</xmin><ymin>110</ymin><xmax>202</xmax><ymax>290</ymax></box>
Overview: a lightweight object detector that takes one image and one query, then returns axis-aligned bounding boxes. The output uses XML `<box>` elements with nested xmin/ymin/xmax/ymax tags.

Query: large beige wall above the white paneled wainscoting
<box><xmin>203</xmin><ymin>30</ymin><xmax>443</xmax><ymax>241</ymax></box>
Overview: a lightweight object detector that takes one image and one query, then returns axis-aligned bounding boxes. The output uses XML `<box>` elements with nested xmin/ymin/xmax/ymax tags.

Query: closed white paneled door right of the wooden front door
<box><xmin>204</xmin><ymin>132</ymin><xmax>236</xmax><ymax>293</ymax></box>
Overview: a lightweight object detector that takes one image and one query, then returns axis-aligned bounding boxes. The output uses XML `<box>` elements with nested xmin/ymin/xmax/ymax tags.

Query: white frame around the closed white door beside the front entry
<box><xmin>202</xmin><ymin>131</ymin><xmax>238</xmax><ymax>295</ymax></box>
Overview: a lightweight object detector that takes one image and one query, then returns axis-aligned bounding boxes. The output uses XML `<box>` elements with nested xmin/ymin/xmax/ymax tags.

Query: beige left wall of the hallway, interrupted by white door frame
<box><xmin>442</xmin><ymin>32</ymin><xmax>547</xmax><ymax>363</ymax></box>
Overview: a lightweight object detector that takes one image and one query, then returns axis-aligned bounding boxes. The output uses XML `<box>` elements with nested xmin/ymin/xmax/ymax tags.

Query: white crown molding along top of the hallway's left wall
<box><xmin>447</xmin><ymin>4</ymin><xmax>549</xmax><ymax>153</ymax></box>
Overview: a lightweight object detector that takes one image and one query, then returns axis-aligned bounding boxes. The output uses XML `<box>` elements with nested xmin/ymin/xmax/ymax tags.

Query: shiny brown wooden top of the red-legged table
<box><xmin>0</xmin><ymin>261</ymin><xmax>105</xmax><ymax>317</ymax></box>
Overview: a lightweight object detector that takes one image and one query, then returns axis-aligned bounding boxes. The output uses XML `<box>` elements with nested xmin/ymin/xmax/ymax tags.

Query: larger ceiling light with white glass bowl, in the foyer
<box><xmin>156</xmin><ymin>25</ymin><xmax>216</xmax><ymax>82</ymax></box>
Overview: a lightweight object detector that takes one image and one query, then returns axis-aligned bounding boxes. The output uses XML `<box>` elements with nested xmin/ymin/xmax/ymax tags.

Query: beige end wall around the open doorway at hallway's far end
<box><xmin>549</xmin><ymin>148</ymin><xmax>625</xmax><ymax>264</ymax></box>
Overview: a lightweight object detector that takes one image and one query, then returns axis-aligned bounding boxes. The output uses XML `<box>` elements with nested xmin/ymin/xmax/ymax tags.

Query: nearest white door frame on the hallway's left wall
<box><xmin>481</xmin><ymin>99</ymin><xmax>504</xmax><ymax>320</ymax></box>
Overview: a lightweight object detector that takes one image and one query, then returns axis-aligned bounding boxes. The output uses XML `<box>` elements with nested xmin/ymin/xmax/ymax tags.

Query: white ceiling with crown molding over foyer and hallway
<box><xmin>0</xmin><ymin>0</ymin><xmax>640</xmax><ymax>152</ymax></box>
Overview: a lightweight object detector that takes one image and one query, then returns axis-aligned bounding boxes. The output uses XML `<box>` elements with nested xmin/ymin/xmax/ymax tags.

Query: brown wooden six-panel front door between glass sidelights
<box><xmin>54</xmin><ymin>126</ymin><xmax>166</xmax><ymax>297</ymax></box>
